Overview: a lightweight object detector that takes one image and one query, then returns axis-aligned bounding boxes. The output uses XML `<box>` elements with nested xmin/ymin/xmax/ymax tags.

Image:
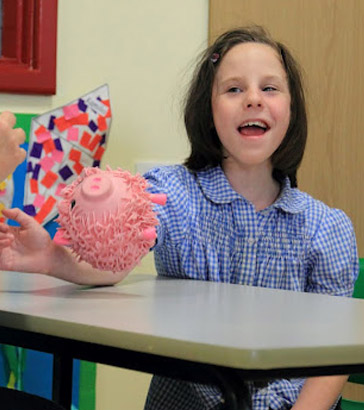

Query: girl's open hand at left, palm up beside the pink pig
<box><xmin>0</xmin><ymin>208</ymin><xmax>54</xmax><ymax>274</ymax></box>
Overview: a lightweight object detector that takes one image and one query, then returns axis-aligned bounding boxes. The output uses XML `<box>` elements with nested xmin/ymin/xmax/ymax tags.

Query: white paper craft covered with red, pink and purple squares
<box><xmin>24</xmin><ymin>85</ymin><xmax>112</xmax><ymax>225</ymax></box>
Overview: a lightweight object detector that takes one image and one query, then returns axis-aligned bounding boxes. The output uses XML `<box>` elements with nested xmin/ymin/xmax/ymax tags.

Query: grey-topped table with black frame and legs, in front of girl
<box><xmin>0</xmin><ymin>272</ymin><xmax>364</xmax><ymax>409</ymax></box>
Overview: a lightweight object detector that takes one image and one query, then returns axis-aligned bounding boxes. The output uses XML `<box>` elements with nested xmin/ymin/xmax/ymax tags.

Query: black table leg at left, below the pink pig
<box><xmin>52</xmin><ymin>354</ymin><xmax>73</xmax><ymax>410</ymax></box>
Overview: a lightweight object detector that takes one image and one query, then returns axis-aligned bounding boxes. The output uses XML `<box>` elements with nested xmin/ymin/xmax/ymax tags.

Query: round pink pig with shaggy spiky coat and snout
<box><xmin>54</xmin><ymin>167</ymin><xmax>167</xmax><ymax>276</ymax></box>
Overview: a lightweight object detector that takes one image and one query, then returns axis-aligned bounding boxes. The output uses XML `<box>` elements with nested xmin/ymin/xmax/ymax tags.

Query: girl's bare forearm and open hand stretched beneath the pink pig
<box><xmin>0</xmin><ymin>209</ymin><xmax>129</xmax><ymax>285</ymax></box>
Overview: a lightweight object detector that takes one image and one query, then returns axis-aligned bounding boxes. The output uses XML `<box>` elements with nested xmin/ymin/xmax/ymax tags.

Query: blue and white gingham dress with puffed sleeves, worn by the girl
<box><xmin>145</xmin><ymin>165</ymin><xmax>359</xmax><ymax>410</ymax></box>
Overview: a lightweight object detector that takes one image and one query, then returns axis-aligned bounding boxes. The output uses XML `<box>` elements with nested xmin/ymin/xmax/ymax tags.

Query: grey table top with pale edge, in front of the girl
<box><xmin>0</xmin><ymin>272</ymin><xmax>364</xmax><ymax>370</ymax></box>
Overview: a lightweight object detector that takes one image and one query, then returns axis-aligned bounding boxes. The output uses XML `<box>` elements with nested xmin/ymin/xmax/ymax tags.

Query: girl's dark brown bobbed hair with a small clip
<box><xmin>184</xmin><ymin>26</ymin><xmax>307</xmax><ymax>187</ymax></box>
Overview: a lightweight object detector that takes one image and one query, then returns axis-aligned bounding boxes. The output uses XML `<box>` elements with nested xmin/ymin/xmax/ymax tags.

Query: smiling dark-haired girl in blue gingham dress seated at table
<box><xmin>0</xmin><ymin>27</ymin><xmax>358</xmax><ymax>410</ymax></box>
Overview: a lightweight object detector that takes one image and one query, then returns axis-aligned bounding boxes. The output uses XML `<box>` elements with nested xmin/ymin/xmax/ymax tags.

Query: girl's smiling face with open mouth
<box><xmin>211</xmin><ymin>43</ymin><xmax>291</xmax><ymax>172</ymax></box>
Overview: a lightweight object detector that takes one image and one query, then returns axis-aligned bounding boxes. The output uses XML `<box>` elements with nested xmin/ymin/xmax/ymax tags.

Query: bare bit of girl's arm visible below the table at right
<box><xmin>292</xmin><ymin>376</ymin><xmax>348</xmax><ymax>410</ymax></box>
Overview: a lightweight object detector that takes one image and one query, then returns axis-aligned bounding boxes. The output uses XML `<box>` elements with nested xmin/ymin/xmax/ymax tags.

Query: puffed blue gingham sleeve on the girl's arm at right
<box><xmin>306</xmin><ymin>208</ymin><xmax>359</xmax><ymax>296</ymax></box>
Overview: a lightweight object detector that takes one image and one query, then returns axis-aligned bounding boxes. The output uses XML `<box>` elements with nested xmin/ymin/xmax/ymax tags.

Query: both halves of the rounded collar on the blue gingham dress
<box><xmin>197</xmin><ymin>166</ymin><xmax>307</xmax><ymax>214</ymax></box>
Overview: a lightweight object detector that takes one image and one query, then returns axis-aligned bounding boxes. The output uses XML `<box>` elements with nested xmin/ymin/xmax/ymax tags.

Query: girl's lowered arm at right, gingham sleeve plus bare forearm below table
<box><xmin>292</xmin><ymin>209</ymin><xmax>359</xmax><ymax>410</ymax></box>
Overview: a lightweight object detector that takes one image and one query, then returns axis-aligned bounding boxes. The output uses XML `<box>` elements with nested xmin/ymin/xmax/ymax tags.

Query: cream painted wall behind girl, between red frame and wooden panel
<box><xmin>0</xmin><ymin>0</ymin><xmax>208</xmax><ymax>410</ymax></box>
